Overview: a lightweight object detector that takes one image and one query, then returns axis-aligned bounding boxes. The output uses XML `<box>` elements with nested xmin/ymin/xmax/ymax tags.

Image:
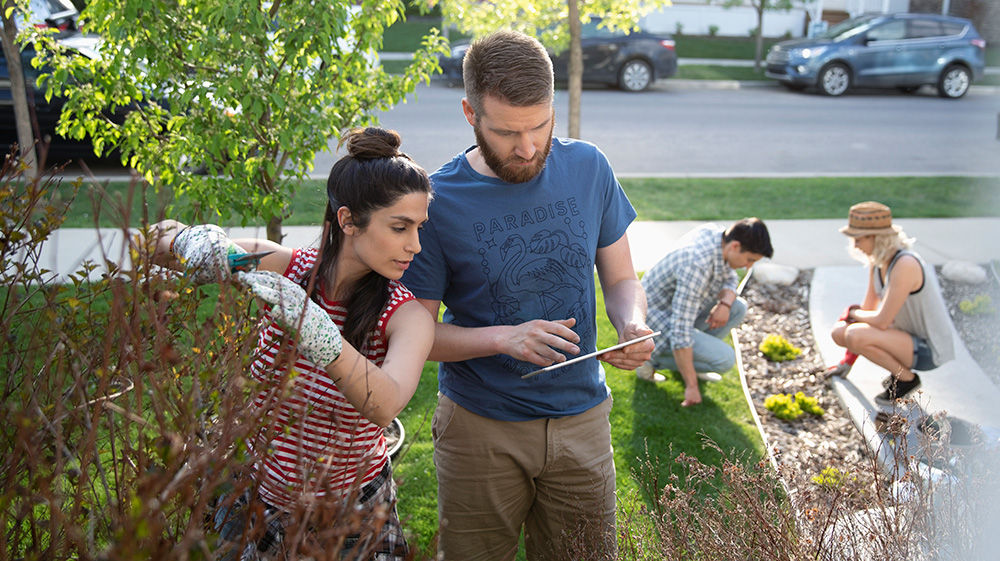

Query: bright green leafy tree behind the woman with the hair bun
<box><xmin>33</xmin><ymin>0</ymin><xmax>446</xmax><ymax>241</ymax></box>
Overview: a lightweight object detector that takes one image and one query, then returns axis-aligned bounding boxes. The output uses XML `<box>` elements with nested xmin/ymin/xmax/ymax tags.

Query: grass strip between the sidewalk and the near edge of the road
<box><xmin>54</xmin><ymin>177</ymin><xmax>1000</xmax><ymax>228</ymax></box>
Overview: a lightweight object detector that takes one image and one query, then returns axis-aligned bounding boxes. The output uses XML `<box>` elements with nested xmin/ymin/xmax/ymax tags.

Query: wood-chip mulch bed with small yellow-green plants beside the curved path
<box><xmin>736</xmin><ymin>264</ymin><xmax>1000</xmax><ymax>509</ymax></box>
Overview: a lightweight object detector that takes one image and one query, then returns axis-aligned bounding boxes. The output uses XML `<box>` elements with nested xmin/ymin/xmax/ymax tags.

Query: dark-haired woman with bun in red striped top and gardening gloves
<box><xmin>149</xmin><ymin>128</ymin><xmax>434</xmax><ymax>560</ymax></box>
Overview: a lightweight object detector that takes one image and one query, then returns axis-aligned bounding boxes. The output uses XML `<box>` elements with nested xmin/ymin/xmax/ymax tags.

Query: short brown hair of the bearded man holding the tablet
<box><xmin>462</xmin><ymin>30</ymin><xmax>555</xmax><ymax>115</ymax></box>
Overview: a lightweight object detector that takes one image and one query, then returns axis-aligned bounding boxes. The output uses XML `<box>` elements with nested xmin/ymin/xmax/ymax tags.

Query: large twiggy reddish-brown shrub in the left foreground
<box><xmin>0</xmin><ymin>158</ymin><xmax>398</xmax><ymax>561</ymax></box>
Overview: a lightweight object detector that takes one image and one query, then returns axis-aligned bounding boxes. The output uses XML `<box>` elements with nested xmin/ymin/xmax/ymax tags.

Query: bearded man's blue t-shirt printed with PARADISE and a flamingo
<box><xmin>403</xmin><ymin>139</ymin><xmax>636</xmax><ymax>421</ymax></box>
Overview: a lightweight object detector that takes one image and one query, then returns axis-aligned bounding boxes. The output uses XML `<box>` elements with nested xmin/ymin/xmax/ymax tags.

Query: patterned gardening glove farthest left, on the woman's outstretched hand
<box><xmin>171</xmin><ymin>224</ymin><xmax>246</xmax><ymax>284</ymax></box>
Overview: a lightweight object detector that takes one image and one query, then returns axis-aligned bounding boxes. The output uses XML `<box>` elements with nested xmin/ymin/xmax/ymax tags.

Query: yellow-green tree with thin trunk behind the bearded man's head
<box><xmin>426</xmin><ymin>0</ymin><xmax>671</xmax><ymax>138</ymax></box>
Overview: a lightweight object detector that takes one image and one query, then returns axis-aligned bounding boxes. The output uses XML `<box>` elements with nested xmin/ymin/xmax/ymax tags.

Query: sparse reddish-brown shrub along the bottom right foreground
<box><xmin>616</xmin><ymin>430</ymin><xmax>1000</xmax><ymax>561</ymax></box>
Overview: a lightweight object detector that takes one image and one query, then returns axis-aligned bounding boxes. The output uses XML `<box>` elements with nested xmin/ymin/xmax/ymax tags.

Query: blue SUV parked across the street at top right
<box><xmin>765</xmin><ymin>14</ymin><xmax>986</xmax><ymax>98</ymax></box>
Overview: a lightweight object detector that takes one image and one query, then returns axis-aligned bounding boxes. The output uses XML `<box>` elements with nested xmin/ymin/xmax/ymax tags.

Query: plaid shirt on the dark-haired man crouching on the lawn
<box><xmin>642</xmin><ymin>224</ymin><xmax>737</xmax><ymax>349</ymax></box>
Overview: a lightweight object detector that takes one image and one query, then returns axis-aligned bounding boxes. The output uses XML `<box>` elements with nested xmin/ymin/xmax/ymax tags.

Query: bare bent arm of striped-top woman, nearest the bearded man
<box><xmin>326</xmin><ymin>300</ymin><xmax>434</xmax><ymax>427</ymax></box>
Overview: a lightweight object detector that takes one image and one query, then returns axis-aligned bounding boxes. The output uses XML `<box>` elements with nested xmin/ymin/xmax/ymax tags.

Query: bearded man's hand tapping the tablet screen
<box><xmin>501</xmin><ymin>318</ymin><xmax>580</xmax><ymax>367</ymax></box>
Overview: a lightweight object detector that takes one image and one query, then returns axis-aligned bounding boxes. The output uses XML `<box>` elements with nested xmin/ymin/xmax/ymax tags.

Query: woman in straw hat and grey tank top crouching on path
<box><xmin>827</xmin><ymin>201</ymin><xmax>955</xmax><ymax>405</ymax></box>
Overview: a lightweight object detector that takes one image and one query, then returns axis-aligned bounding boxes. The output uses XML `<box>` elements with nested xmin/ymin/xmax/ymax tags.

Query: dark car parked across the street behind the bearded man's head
<box><xmin>440</xmin><ymin>18</ymin><xmax>677</xmax><ymax>92</ymax></box>
